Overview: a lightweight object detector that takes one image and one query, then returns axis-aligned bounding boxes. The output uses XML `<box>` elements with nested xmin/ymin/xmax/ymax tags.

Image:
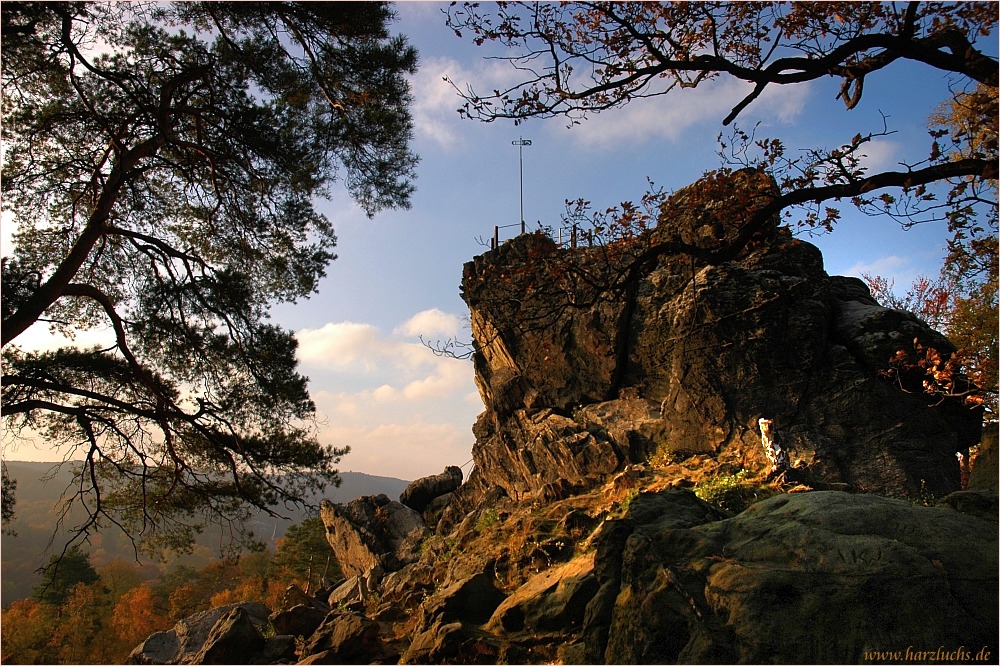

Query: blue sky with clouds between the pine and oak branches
<box><xmin>4</xmin><ymin>2</ymin><xmax>988</xmax><ymax>479</ymax></box>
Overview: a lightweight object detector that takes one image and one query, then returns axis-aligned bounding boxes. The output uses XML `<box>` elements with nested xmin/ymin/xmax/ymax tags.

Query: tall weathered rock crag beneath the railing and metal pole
<box><xmin>462</xmin><ymin>208</ymin><xmax>981</xmax><ymax>496</ymax></box>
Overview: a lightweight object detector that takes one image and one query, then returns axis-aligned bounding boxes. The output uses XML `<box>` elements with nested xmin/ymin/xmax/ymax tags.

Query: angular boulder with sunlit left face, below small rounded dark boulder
<box><xmin>320</xmin><ymin>495</ymin><xmax>430</xmax><ymax>578</ymax></box>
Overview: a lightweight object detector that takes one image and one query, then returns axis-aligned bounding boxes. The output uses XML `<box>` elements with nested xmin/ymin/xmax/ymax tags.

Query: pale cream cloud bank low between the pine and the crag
<box><xmin>296</xmin><ymin>308</ymin><xmax>482</xmax><ymax>479</ymax></box>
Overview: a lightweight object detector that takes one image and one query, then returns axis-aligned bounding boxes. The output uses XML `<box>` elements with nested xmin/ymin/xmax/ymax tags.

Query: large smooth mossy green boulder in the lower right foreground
<box><xmin>584</xmin><ymin>491</ymin><xmax>998</xmax><ymax>664</ymax></box>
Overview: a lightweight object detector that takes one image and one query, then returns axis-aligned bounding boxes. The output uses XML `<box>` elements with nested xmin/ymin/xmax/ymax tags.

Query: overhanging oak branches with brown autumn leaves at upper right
<box><xmin>448</xmin><ymin>2</ymin><xmax>998</xmax><ymax>410</ymax></box>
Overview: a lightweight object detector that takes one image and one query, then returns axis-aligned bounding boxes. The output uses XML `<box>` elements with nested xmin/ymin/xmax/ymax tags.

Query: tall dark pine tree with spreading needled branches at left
<box><xmin>2</xmin><ymin>2</ymin><xmax>416</xmax><ymax>552</ymax></box>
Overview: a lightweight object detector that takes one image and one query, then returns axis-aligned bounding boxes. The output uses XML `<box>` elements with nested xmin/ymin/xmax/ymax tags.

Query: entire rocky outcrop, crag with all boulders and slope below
<box><xmin>132</xmin><ymin>184</ymin><xmax>1000</xmax><ymax>664</ymax></box>
